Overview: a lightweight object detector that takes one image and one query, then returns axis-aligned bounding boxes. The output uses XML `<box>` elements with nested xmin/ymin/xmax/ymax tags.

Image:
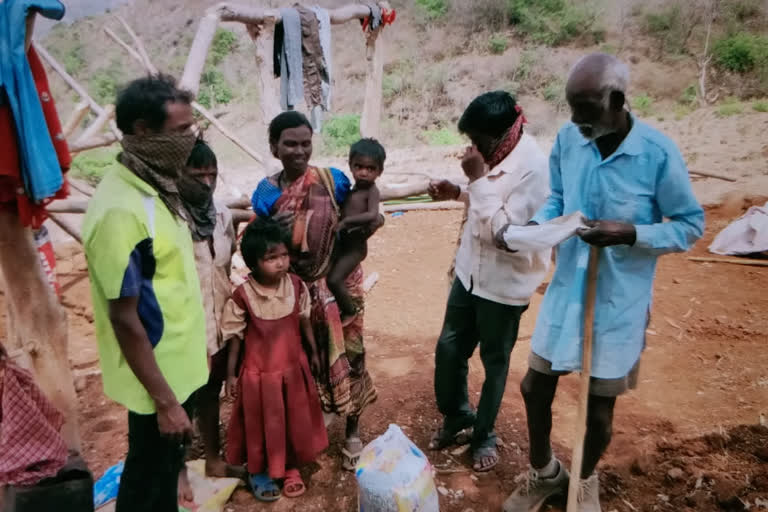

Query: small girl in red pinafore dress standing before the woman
<box><xmin>222</xmin><ymin>219</ymin><xmax>328</xmax><ymax>501</ymax></box>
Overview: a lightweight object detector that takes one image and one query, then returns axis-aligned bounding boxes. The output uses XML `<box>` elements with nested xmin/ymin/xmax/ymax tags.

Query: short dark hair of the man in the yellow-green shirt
<box><xmin>115</xmin><ymin>74</ymin><xmax>193</xmax><ymax>135</ymax></box>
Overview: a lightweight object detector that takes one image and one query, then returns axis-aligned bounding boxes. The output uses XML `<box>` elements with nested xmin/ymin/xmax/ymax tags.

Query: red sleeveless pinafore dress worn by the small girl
<box><xmin>227</xmin><ymin>274</ymin><xmax>328</xmax><ymax>479</ymax></box>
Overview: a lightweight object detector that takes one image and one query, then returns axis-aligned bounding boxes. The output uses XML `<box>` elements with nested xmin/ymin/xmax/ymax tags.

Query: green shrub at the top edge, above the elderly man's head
<box><xmin>507</xmin><ymin>0</ymin><xmax>605</xmax><ymax>46</ymax></box>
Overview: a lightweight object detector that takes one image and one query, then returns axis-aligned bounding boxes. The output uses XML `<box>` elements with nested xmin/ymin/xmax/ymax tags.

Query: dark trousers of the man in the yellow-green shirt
<box><xmin>115</xmin><ymin>395</ymin><xmax>194</xmax><ymax>512</ymax></box>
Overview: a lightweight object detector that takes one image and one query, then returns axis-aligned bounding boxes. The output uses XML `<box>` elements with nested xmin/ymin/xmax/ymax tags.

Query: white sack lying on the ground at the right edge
<box><xmin>709</xmin><ymin>203</ymin><xmax>768</xmax><ymax>256</ymax></box>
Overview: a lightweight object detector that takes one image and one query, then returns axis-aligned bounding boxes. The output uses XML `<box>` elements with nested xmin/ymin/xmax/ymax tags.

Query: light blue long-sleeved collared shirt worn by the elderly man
<box><xmin>531</xmin><ymin>118</ymin><xmax>704</xmax><ymax>379</ymax></box>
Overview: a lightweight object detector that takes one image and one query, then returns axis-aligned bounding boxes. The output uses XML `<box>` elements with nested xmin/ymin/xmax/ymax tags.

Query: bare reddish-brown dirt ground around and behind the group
<box><xmin>3</xmin><ymin>199</ymin><xmax>768</xmax><ymax>512</ymax></box>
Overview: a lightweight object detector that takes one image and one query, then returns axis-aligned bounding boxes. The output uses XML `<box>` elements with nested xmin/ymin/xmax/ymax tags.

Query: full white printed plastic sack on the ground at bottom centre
<box><xmin>355</xmin><ymin>425</ymin><xmax>440</xmax><ymax>512</ymax></box>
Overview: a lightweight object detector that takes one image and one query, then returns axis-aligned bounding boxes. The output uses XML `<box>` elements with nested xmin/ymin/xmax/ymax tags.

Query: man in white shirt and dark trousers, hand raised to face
<box><xmin>429</xmin><ymin>91</ymin><xmax>550</xmax><ymax>472</ymax></box>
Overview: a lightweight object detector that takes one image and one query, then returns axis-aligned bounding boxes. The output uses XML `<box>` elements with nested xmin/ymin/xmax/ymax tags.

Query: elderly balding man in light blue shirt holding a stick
<box><xmin>496</xmin><ymin>54</ymin><xmax>704</xmax><ymax>512</ymax></box>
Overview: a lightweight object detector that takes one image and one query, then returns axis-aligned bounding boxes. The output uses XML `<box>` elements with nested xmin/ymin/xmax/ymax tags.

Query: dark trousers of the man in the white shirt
<box><xmin>435</xmin><ymin>278</ymin><xmax>528</xmax><ymax>449</ymax></box>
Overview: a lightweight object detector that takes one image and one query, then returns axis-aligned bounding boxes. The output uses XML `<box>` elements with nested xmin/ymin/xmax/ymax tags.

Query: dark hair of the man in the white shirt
<box><xmin>459</xmin><ymin>91</ymin><xmax>520</xmax><ymax>137</ymax></box>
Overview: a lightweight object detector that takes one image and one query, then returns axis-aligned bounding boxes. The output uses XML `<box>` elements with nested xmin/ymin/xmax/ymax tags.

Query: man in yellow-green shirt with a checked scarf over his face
<box><xmin>83</xmin><ymin>76</ymin><xmax>208</xmax><ymax>512</ymax></box>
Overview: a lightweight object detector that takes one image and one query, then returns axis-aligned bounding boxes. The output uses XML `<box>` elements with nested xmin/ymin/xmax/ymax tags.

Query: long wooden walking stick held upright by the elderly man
<box><xmin>566</xmin><ymin>246</ymin><xmax>600</xmax><ymax>512</ymax></box>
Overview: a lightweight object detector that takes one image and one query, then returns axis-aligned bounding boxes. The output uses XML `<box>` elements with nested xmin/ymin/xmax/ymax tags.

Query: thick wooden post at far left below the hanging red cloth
<box><xmin>0</xmin><ymin>211</ymin><xmax>80</xmax><ymax>452</ymax></box>
